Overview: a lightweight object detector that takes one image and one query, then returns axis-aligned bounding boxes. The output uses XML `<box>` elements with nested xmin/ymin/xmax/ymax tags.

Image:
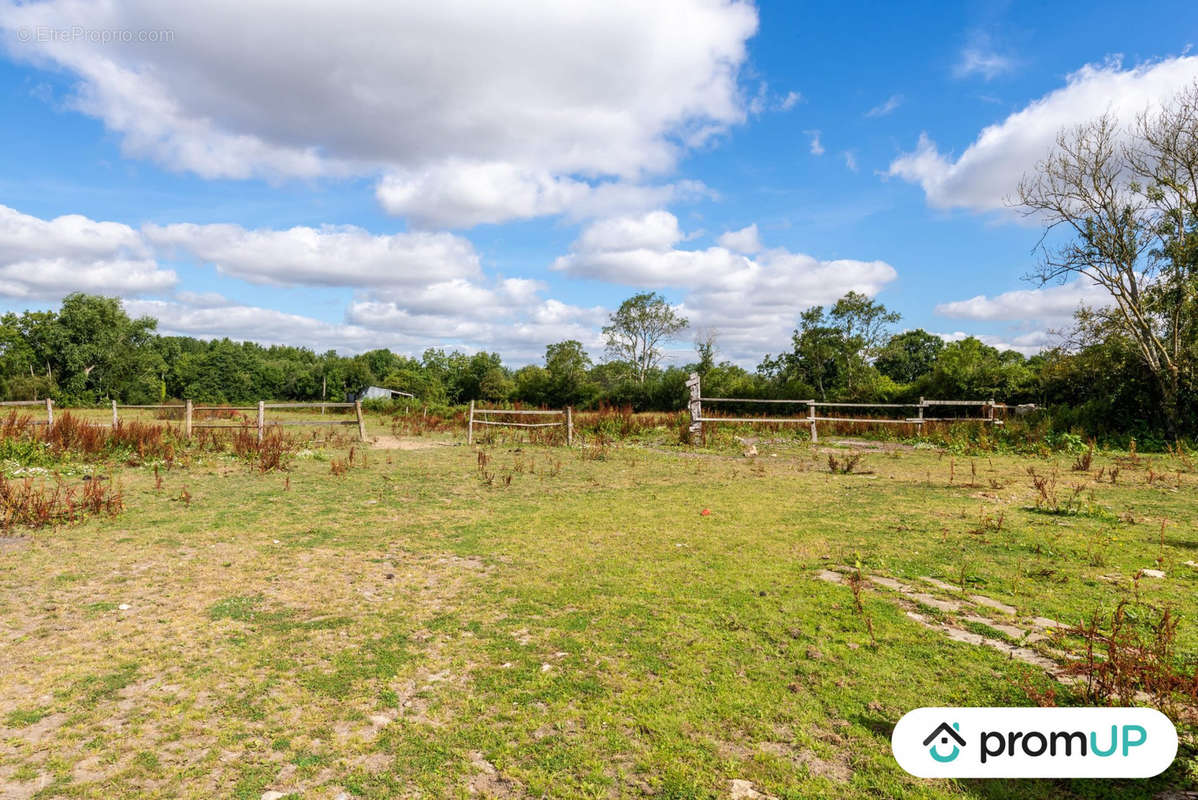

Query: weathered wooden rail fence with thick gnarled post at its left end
<box><xmin>686</xmin><ymin>372</ymin><xmax>1009</xmax><ymax>442</ymax></box>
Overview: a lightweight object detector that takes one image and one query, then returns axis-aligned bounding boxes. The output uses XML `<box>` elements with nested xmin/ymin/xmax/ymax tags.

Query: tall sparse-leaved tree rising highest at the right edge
<box><xmin>1015</xmin><ymin>81</ymin><xmax>1198</xmax><ymax>436</ymax></box>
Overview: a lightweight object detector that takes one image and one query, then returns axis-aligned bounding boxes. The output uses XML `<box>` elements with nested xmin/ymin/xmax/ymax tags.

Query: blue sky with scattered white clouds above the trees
<box><xmin>0</xmin><ymin>0</ymin><xmax>1198</xmax><ymax>365</ymax></box>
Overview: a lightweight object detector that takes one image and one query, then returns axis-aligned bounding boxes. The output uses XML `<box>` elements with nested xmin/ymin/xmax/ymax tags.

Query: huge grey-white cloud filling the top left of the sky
<box><xmin>0</xmin><ymin>0</ymin><xmax>757</xmax><ymax>224</ymax></box>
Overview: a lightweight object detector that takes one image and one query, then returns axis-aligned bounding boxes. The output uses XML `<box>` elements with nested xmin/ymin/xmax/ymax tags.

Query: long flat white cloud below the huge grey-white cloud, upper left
<box><xmin>144</xmin><ymin>223</ymin><xmax>480</xmax><ymax>286</ymax></box>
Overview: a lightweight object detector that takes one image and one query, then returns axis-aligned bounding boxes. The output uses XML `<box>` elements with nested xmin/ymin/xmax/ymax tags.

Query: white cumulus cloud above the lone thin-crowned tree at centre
<box><xmin>552</xmin><ymin>211</ymin><xmax>897</xmax><ymax>360</ymax></box>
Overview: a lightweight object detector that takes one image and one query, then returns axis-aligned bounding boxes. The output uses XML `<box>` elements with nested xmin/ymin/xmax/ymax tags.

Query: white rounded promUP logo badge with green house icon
<box><xmin>890</xmin><ymin>708</ymin><xmax>1178</xmax><ymax>777</ymax></box>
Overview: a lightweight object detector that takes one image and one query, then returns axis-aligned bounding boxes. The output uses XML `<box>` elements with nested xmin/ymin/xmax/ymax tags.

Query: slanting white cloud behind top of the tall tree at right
<box><xmin>889</xmin><ymin>56</ymin><xmax>1198</xmax><ymax>211</ymax></box>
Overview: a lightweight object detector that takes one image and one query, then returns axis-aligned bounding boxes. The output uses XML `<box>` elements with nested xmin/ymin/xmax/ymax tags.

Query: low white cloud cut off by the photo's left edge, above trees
<box><xmin>0</xmin><ymin>206</ymin><xmax>177</xmax><ymax>299</ymax></box>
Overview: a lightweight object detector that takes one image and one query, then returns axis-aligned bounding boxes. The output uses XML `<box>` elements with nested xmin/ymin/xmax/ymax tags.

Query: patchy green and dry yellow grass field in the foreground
<box><xmin>0</xmin><ymin>419</ymin><xmax>1198</xmax><ymax>800</ymax></box>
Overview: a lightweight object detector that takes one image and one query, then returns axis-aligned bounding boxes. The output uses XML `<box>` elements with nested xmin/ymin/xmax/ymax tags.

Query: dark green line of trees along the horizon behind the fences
<box><xmin>0</xmin><ymin>283</ymin><xmax>1198</xmax><ymax>436</ymax></box>
